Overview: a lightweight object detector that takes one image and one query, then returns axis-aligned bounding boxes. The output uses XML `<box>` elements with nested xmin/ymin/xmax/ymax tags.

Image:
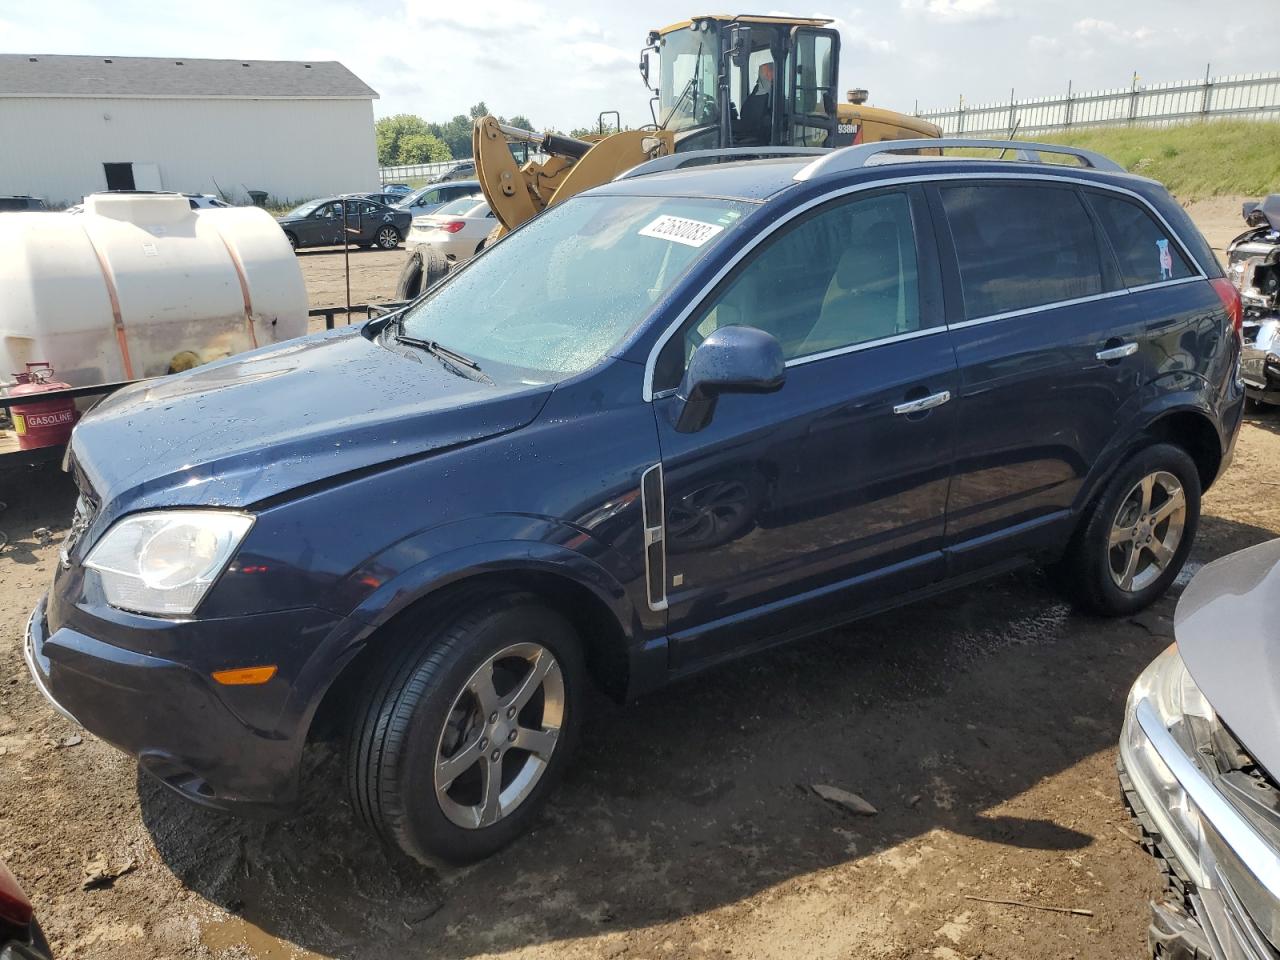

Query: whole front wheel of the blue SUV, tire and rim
<box><xmin>347</xmin><ymin>595</ymin><xmax>584</xmax><ymax>863</ymax></box>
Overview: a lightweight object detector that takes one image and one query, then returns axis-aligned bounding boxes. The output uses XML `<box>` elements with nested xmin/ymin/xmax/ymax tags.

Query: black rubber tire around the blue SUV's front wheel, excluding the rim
<box><xmin>347</xmin><ymin>594</ymin><xmax>585</xmax><ymax>864</ymax></box>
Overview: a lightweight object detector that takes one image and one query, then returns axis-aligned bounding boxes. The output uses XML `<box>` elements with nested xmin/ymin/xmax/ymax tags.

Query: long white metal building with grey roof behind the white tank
<box><xmin>0</xmin><ymin>54</ymin><xmax>379</xmax><ymax>205</ymax></box>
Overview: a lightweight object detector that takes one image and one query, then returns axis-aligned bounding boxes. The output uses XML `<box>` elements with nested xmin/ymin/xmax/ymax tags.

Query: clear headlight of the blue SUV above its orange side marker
<box><xmin>84</xmin><ymin>509</ymin><xmax>253</xmax><ymax>616</ymax></box>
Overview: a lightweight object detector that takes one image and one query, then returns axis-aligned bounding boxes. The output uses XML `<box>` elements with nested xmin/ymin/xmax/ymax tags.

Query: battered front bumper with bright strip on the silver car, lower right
<box><xmin>1117</xmin><ymin>699</ymin><xmax>1280</xmax><ymax>960</ymax></box>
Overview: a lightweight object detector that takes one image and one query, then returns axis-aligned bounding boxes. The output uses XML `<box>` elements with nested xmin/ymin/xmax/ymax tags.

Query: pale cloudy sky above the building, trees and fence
<box><xmin>0</xmin><ymin>0</ymin><xmax>1280</xmax><ymax>131</ymax></box>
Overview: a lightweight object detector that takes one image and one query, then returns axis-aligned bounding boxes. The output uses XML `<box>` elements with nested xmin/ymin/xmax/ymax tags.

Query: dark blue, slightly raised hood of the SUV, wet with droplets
<box><xmin>72</xmin><ymin>326</ymin><xmax>552</xmax><ymax>518</ymax></box>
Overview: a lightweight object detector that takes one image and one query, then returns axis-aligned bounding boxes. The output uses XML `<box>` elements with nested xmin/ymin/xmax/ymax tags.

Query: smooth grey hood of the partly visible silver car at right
<box><xmin>1174</xmin><ymin>540</ymin><xmax>1280</xmax><ymax>777</ymax></box>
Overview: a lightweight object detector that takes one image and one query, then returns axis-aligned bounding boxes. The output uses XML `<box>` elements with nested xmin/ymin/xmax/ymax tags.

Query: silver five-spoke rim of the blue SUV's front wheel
<box><xmin>435</xmin><ymin>643</ymin><xmax>564</xmax><ymax>829</ymax></box>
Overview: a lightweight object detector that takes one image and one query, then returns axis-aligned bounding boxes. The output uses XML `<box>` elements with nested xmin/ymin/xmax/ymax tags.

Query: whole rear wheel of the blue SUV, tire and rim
<box><xmin>1060</xmin><ymin>443</ymin><xmax>1201</xmax><ymax>616</ymax></box>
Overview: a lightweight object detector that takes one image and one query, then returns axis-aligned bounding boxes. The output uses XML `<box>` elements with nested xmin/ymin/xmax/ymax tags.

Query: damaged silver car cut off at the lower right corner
<box><xmin>1120</xmin><ymin>540</ymin><xmax>1280</xmax><ymax>960</ymax></box>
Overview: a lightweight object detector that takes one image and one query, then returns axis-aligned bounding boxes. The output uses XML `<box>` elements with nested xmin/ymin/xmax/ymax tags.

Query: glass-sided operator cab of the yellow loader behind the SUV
<box><xmin>641</xmin><ymin>17</ymin><xmax>840</xmax><ymax>152</ymax></box>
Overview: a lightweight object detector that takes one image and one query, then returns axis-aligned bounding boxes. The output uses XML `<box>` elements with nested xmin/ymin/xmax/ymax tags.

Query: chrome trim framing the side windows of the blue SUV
<box><xmin>641</xmin><ymin>172</ymin><xmax>1208</xmax><ymax>403</ymax></box>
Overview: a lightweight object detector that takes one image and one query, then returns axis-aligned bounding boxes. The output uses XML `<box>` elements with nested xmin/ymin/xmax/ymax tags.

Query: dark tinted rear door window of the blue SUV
<box><xmin>938</xmin><ymin>183</ymin><xmax>1105</xmax><ymax>320</ymax></box>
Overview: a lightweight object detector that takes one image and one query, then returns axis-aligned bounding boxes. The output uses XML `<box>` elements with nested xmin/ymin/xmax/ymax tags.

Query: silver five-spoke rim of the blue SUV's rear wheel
<box><xmin>1107</xmin><ymin>470</ymin><xmax>1187</xmax><ymax>593</ymax></box>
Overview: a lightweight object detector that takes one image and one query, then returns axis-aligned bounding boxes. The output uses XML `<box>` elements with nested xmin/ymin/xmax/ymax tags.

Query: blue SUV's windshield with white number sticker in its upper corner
<box><xmin>404</xmin><ymin>196</ymin><xmax>751</xmax><ymax>383</ymax></box>
